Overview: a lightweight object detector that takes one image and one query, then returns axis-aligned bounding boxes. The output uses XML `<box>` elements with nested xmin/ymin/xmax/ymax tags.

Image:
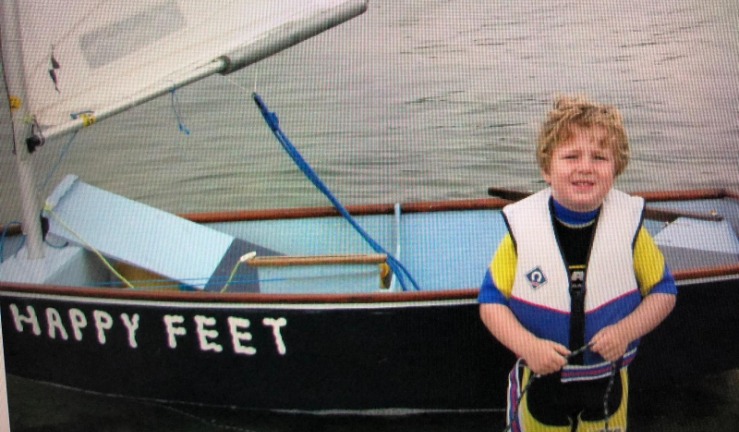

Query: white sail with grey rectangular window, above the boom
<box><xmin>2</xmin><ymin>0</ymin><xmax>367</xmax><ymax>138</ymax></box>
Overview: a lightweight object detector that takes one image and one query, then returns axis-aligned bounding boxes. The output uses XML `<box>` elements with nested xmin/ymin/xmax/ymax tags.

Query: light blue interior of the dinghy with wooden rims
<box><xmin>0</xmin><ymin>182</ymin><xmax>739</xmax><ymax>294</ymax></box>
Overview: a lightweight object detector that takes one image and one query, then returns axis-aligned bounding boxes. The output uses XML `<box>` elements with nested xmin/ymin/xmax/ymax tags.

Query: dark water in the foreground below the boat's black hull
<box><xmin>8</xmin><ymin>371</ymin><xmax>739</xmax><ymax>432</ymax></box>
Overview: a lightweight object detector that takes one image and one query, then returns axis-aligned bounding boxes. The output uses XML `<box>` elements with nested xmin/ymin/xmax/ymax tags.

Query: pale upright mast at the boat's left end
<box><xmin>0</xmin><ymin>1</ymin><xmax>44</xmax><ymax>259</ymax></box>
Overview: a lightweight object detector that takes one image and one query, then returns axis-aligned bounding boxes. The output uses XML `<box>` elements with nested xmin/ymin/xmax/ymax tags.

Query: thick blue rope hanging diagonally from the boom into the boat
<box><xmin>253</xmin><ymin>93</ymin><xmax>420</xmax><ymax>291</ymax></box>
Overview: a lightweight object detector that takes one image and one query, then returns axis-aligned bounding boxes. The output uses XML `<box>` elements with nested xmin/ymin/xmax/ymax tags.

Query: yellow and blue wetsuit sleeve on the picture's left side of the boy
<box><xmin>477</xmin><ymin>234</ymin><xmax>518</xmax><ymax>305</ymax></box>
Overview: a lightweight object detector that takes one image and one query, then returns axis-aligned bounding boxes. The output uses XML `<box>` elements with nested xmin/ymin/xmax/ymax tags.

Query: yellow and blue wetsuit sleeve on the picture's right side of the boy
<box><xmin>634</xmin><ymin>227</ymin><xmax>677</xmax><ymax>297</ymax></box>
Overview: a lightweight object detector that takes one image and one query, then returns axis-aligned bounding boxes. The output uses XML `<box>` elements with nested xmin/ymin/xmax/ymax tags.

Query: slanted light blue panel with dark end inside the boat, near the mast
<box><xmin>45</xmin><ymin>175</ymin><xmax>279</xmax><ymax>292</ymax></box>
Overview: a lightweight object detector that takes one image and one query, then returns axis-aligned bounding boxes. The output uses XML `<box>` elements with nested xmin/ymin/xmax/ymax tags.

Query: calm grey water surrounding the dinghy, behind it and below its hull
<box><xmin>0</xmin><ymin>0</ymin><xmax>739</xmax><ymax>431</ymax></box>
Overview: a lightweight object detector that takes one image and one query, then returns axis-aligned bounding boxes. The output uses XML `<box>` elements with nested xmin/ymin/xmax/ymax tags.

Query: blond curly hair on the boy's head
<box><xmin>536</xmin><ymin>96</ymin><xmax>630</xmax><ymax>176</ymax></box>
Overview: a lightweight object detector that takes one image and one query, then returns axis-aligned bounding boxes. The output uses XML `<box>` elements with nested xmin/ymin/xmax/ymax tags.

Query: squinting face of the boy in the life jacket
<box><xmin>543</xmin><ymin>127</ymin><xmax>616</xmax><ymax>212</ymax></box>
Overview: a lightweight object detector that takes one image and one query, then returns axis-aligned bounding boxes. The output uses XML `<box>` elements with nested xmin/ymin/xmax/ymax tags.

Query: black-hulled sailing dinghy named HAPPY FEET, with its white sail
<box><xmin>0</xmin><ymin>0</ymin><xmax>739</xmax><ymax>413</ymax></box>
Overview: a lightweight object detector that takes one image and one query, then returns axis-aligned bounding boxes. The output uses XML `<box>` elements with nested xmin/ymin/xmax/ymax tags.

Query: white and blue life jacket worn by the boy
<box><xmin>503</xmin><ymin>189</ymin><xmax>644</xmax><ymax>379</ymax></box>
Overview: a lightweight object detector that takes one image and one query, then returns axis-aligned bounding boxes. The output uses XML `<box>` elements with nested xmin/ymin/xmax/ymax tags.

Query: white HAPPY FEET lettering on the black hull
<box><xmin>9</xmin><ymin>303</ymin><xmax>287</xmax><ymax>356</ymax></box>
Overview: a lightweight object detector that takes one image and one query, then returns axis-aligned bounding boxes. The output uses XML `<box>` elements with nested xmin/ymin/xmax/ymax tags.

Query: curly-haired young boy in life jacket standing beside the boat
<box><xmin>479</xmin><ymin>97</ymin><xmax>677</xmax><ymax>432</ymax></box>
